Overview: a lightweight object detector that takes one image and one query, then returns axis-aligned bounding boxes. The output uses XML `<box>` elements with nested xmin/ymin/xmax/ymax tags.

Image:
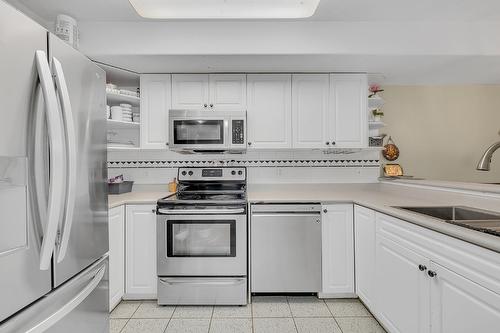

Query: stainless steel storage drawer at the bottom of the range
<box><xmin>158</xmin><ymin>277</ymin><xmax>247</xmax><ymax>305</ymax></box>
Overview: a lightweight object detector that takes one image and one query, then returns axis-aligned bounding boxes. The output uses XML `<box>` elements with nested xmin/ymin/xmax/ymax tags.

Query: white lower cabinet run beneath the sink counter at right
<box><xmin>354</xmin><ymin>210</ymin><xmax>500</xmax><ymax>333</ymax></box>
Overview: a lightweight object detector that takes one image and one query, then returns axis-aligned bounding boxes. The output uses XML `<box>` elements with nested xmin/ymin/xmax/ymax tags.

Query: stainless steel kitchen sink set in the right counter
<box><xmin>394</xmin><ymin>206</ymin><xmax>500</xmax><ymax>236</ymax></box>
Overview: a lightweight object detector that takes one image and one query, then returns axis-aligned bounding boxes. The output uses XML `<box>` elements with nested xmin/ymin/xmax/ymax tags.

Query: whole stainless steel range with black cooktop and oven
<box><xmin>157</xmin><ymin>167</ymin><xmax>247</xmax><ymax>305</ymax></box>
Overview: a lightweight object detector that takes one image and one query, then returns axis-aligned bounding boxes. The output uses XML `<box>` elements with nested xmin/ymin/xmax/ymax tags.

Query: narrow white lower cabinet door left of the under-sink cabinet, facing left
<box><xmin>354</xmin><ymin>206</ymin><xmax>376</xmax><ymax>311</ymax></box>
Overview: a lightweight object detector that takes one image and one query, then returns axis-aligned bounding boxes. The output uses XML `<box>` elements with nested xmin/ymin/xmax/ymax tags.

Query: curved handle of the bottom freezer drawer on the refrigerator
<box><xmin>26</xmin><ymin>265</ymin><xmax>106</xmax><ymax>333</ymax></box>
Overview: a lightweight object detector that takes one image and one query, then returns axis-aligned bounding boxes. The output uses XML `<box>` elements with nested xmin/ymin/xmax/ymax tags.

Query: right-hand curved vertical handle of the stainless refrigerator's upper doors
<box><xmin>52</xmin><ymin>57</ymin><xmax>77</xmax><ymax>262</ymax></box>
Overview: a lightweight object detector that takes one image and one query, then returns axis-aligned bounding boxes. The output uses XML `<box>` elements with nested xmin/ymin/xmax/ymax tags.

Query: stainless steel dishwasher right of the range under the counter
<box><xmin>250</xmin><ymin>204</ymin><xmax>321</xmax><ymax>293</ymax></box>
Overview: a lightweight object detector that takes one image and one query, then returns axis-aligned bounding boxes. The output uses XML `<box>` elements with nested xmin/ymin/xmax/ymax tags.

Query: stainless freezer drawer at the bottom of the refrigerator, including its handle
<box><xmin>0</xmin><ymin>256</ymin><xmax>109</xmax><ymax>333</ymax></box>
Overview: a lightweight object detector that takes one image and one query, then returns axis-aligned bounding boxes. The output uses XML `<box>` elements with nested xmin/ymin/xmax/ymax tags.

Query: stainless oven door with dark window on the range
<box><xmin>157</xmin><ymin>215</ymin><xmax>247</xmax><ymax>276</ymax></box>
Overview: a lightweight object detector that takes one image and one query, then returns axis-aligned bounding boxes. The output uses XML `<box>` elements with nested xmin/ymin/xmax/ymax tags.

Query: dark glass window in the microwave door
<box><xmin>174</xmin><ymin>120</ymin><xmax>224</xmax><ymax>145</ymax></box>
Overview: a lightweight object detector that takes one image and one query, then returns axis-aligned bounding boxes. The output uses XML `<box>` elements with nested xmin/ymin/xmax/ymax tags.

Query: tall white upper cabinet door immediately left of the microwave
<box><xmin>141</xmin><ymin>74</ymin><xmax>172</xmax><ymax>149</ymax></box>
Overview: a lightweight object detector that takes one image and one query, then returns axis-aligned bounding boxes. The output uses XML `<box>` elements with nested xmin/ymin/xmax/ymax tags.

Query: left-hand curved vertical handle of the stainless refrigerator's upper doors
<box><xmin>35</xmin><ymin>50</ymin><xmax>66</xmax><ymax>270</ymax></box>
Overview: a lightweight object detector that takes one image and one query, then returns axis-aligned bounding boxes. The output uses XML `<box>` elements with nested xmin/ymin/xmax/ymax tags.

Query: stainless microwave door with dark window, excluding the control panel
<box><xmin>169</xmin><ymin>117</ymin><xmax>229</xmax><ymax>150</ymax></box>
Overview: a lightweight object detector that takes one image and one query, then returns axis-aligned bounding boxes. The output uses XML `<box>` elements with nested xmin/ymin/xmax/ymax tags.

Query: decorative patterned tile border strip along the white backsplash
<box><xmin>108</xmin><ymin>158</ymin><xmax>380</xmax><ymax>169</ymax></box>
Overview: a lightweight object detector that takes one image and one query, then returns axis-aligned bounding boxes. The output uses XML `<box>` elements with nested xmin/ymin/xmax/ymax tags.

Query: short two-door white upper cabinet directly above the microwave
<box><xmin>172</xmin><ymin>74</ymin><xmax>247</xmax><ymax>111</ymax></box>
